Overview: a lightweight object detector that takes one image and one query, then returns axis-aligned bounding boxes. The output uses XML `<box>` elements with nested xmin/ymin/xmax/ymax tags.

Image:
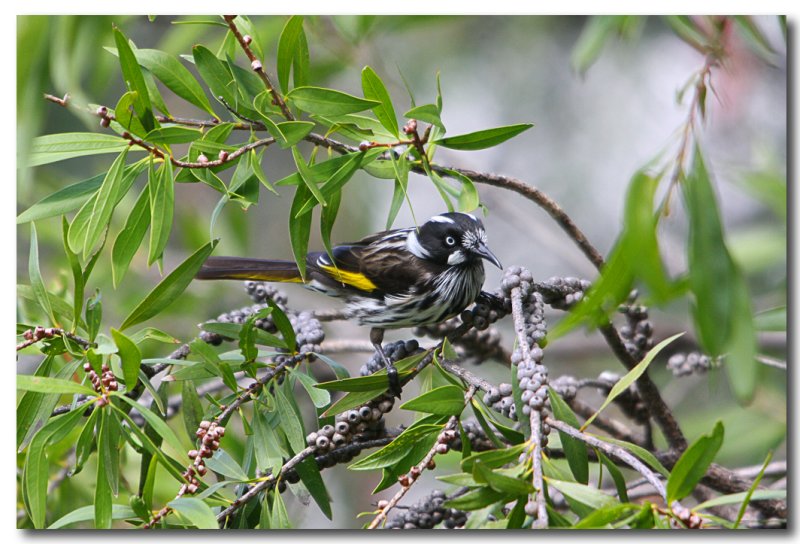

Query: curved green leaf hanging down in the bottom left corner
<box><xmin>22</xmin><ymin>410</ymin><xmax>83</xmax><ymax>529</ymax></box>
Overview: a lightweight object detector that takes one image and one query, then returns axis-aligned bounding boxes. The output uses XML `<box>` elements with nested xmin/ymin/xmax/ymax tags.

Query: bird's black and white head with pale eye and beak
<box><xmin>407</xmin><ymin>212</ymin><xmax>503</xmax><ymax>269</ymax></box>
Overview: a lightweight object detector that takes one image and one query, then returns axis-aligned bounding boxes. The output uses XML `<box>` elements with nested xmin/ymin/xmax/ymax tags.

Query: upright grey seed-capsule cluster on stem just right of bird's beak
<box><xmin>500</xmin><ymin>266</ymin><xmax>550</xmax><ymax>447</ymax></box>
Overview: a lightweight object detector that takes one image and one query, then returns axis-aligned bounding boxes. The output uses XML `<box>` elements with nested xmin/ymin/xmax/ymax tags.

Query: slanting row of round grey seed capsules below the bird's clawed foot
<box><xmin>306</xmin><ymin>395</ymin><xmax>394</xmax><ymax>453</ymax></box>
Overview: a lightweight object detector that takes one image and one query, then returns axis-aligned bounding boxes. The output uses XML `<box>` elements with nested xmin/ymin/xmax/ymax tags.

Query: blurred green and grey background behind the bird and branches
<box><xmin>17</xmin><ymin>16</ymin><xmax>787</xmax><ymax>527</ymax></box>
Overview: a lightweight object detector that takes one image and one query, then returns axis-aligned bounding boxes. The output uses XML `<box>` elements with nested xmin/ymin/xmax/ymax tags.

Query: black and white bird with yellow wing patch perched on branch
<box><xmin>197</xmin><ymin>213</ymin><xmax>502</xmax><ymax>396</ymax></box>
